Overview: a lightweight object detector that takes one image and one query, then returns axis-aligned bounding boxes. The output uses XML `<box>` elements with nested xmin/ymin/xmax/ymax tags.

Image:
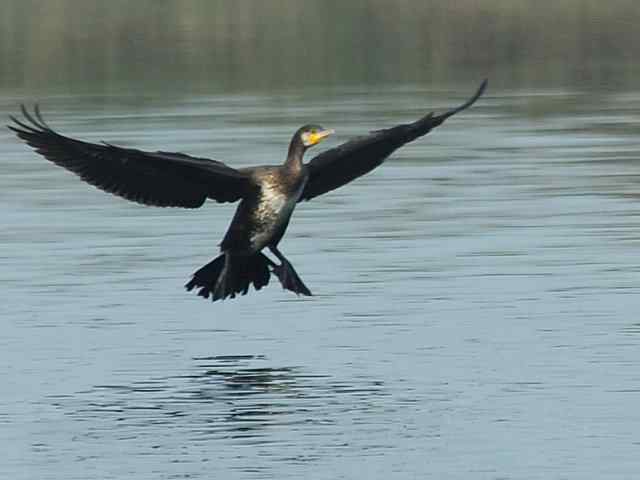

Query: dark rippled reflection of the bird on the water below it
<box><xmin>53</xmin><ymin>355</ymin><xmax>384</xmax><ymax>445</ymax></box>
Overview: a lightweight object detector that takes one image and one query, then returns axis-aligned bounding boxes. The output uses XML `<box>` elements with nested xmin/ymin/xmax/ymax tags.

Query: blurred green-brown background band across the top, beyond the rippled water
<box><xmin>0</xmin><ymin>0</ymin><xmax>640</xmax><ymax>93</ymax></box>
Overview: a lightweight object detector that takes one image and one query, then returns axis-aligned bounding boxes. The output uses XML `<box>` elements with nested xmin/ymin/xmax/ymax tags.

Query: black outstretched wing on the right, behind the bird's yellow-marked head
<box><xmin>300</xmin><ymin>80</ymin><xmax>487</xmax><ymax>200</ymax></box>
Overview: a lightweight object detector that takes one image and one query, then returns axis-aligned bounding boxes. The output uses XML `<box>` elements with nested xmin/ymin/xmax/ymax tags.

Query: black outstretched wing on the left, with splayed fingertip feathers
<box><xmin>9</xmin><ymin>106</ymin><xmax>251</xmax><ymax>208</ymax></box>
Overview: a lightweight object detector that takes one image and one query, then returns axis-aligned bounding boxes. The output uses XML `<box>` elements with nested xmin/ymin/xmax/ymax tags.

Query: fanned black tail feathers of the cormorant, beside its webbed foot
<box><xmin>185</xmin><ymin>253</ymin><xmax>272</xmax><ymax>302</ymax></box>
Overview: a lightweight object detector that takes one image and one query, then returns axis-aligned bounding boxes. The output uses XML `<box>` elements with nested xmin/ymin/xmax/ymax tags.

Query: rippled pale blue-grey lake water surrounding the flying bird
<box><xmin>0</xmin><ymin>84</ymin><xmax>640</xmax><ymax>480</ymax></box>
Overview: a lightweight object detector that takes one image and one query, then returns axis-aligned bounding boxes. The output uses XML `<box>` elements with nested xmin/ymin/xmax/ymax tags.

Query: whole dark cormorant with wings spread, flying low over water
<box><xmin>9</xmin><ymin>80</ymin><xmax>487</xmax><ymax>301</ymax></box>
